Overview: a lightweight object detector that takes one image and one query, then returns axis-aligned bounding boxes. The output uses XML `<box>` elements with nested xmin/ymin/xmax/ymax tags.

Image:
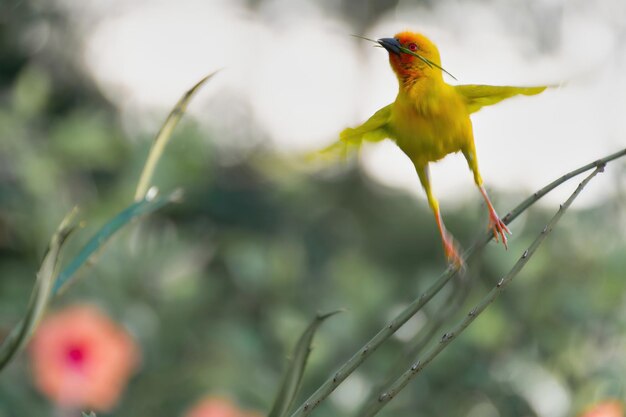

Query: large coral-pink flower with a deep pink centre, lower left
<box><xmin>30</xmin><ymin>305</ymin><xmax>139</xmax><ymax>411</ymax></box>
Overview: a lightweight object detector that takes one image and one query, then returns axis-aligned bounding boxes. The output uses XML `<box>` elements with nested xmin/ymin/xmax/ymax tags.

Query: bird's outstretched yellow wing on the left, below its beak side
<box><xmin>318</xmin><ymin>104</ymin><xmax>392</xmax><ymax>158</ymax></box>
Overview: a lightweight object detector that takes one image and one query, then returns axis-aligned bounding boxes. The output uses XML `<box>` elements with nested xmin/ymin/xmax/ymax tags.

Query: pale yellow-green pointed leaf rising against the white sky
<box><xmin>135</xmin><ymin>71</ymin><xmax>217</xmax><ymax>201</ymax></box>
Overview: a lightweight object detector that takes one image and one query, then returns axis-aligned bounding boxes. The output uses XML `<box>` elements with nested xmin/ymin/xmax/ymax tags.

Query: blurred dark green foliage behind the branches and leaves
<box><xmin>0</xmin><ymin>0</ymin><xmax>626</xmax><ymax>417</ymax></box>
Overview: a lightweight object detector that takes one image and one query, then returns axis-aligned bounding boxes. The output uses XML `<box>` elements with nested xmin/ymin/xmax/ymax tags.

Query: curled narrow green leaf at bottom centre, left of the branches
<box><xmin>268</xmin><ymin>310</ymin><xmax>342</xmax><ymax>417</ymax></box>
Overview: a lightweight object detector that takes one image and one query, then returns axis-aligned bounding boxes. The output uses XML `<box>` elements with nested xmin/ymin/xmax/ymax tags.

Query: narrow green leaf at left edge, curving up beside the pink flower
<box><xmin>0</xmin><ymin>209</ymin><xmax>77</xmax><ymax>371</ymax></box>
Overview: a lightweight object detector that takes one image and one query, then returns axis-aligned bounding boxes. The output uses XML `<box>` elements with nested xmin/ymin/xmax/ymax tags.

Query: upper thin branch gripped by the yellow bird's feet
<box><xmin>291</xmin><ymin>149</ymin><xmax>626</xmax><ymax>417</ymax></box>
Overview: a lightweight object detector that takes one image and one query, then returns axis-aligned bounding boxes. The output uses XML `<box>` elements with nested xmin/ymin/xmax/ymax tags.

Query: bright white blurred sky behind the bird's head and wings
<box><xmin>59</xmin><ymin>0</ymin><xmax>626</xmax><ymax>206</ymax></box>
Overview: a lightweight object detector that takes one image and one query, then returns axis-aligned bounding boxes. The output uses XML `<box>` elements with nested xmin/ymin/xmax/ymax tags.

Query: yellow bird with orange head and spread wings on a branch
<box><xmin>321</xmin><ymin>31</ymin><xmax>547</xmax><ymax>267</ymax></box>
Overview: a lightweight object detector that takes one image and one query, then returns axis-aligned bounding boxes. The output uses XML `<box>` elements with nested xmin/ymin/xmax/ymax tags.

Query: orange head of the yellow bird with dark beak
<box><xmin>378</xmin><ymin>31</ymin><xmax>442</xmax><ymax>83</ymax></box>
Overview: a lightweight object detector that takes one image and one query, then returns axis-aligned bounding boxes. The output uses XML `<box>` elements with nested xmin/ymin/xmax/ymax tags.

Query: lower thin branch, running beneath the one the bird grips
<box><xmin>362</xmin><ymin>165</ymin><xmax>604</xmax><ymax>417</ymax></box>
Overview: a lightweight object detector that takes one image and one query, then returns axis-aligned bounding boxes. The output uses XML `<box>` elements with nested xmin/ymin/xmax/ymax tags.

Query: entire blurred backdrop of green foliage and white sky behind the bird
<box><xmin>0</xmin><ymin>0</ymin><xmax>626</xmax><ymax>417</ymax></box>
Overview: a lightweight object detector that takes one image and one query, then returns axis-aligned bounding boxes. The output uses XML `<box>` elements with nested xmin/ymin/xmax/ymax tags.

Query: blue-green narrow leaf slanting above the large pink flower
<box><xmin>52</xmin><ymin>191</ymin><xmax>180</xmax><ymax>295</ymax></box>
